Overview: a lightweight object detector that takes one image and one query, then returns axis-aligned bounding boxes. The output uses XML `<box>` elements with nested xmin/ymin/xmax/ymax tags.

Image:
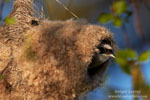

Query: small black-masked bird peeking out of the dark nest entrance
<box><xmin>88</xmin><ymin>41</ymin><xmax>115</xmax><ymax>76</ymax></box>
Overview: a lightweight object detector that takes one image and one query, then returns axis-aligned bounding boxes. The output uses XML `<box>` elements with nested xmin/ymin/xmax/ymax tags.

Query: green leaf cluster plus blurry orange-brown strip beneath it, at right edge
<box><xmin>116</xmin><ymin>49</ymin><xmax>150</xmax><ymax>100</ymax></box>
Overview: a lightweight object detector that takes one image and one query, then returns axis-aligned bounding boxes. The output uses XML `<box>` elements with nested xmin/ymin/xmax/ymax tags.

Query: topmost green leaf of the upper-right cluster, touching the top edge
<box><xmin>112</xmin><ymin>0</ymin><xmax>128</xmax><ymax>15</ymax></box>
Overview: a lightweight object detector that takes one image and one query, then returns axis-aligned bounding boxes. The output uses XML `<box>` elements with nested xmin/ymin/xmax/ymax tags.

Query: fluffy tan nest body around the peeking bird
<box><xmin>0</xmin><ymin>20</ymin><xmax>115</xmax><ymax>100</ymax></box>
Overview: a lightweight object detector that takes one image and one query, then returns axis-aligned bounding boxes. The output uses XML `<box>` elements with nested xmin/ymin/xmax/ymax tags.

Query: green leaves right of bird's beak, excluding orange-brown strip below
<box><xmin>116</xmin><ymin>49</ymin><xmax>150</xmax><ymax>74</ymax></box>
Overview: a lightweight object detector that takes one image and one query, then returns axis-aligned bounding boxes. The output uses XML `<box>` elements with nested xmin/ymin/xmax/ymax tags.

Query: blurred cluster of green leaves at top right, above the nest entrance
<box><xmin>99</xmin><ymin>0</ymin><xmax>132</xmax><ymax>27</ymax></box>
